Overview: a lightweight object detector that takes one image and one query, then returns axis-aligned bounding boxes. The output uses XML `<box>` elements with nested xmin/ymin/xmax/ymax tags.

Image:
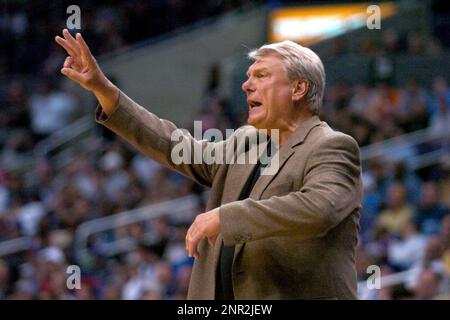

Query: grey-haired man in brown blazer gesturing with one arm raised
<box><xmin>56</xmin><ymin>30</ymin><xmax>361</xmax><ymax>299</ymax></box>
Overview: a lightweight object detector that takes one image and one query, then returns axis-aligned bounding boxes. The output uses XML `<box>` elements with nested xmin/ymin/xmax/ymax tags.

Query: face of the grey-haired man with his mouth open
<box><xmin>242</xmin><ymin>55</ymin><xmax>294</xmax><ymax>129</ymax></box>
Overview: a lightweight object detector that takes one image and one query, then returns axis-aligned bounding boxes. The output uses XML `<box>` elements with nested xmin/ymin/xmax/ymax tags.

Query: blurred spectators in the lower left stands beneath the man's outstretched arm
<box><xmin>0</xmin><ymin>83</ymin><xmax>206</xmax><ymax>299</ymax></box>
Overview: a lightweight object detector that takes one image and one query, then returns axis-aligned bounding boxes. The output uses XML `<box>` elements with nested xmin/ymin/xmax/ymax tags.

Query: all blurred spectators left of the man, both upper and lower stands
<box><xmin>0</xmin><ymin>0</ymin><xmax>256</xmax><ymax>299</ymax></box>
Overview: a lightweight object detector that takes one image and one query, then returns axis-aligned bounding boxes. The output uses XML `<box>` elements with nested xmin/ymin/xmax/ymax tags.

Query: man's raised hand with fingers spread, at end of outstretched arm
<box><xmin>55</xmin><ymin>29</ymin><xmax>119</xmax><ymax>114</ymax></box>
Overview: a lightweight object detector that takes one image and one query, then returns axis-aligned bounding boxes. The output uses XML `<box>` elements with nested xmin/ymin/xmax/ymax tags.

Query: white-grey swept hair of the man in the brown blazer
<box><xmin>248</xmin><ymin>40</ymin><xmax>325</xmax><ymax>114</ymax></box>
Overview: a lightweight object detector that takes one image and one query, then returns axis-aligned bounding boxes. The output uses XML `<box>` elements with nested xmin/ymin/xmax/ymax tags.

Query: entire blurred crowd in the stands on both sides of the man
<box><xmin>0</xmin><ymin>1</ymin><xmax>450</xmax><ymax>299</ymax></box>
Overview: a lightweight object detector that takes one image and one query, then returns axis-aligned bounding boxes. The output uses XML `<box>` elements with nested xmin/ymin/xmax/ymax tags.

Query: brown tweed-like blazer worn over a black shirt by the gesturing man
<box><xmin>96</xmin><ymin>92</ymin><xmax>362</xmax><ymax>299</ymax></box>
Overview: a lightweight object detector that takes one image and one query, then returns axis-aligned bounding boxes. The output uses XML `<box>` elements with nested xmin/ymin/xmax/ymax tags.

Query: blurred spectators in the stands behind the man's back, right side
<box><xmin>322</xmin><ymin>30</ymin><xmax>450</xmax><ymax>300</ymax></box>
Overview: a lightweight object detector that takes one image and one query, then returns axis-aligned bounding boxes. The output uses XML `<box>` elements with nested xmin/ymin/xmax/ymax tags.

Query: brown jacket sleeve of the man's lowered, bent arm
<box><xmin>219</xmin><ymin>133</ymin><xmax>362</xmax><ymax>245</ymax></box>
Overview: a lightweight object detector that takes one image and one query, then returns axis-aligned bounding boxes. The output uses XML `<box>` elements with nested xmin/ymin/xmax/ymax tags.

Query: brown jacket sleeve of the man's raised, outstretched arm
<box><xmin>95</xmin><ymin>91</ymin><xmax>243</xmax><ymax>186</ymax></box>
